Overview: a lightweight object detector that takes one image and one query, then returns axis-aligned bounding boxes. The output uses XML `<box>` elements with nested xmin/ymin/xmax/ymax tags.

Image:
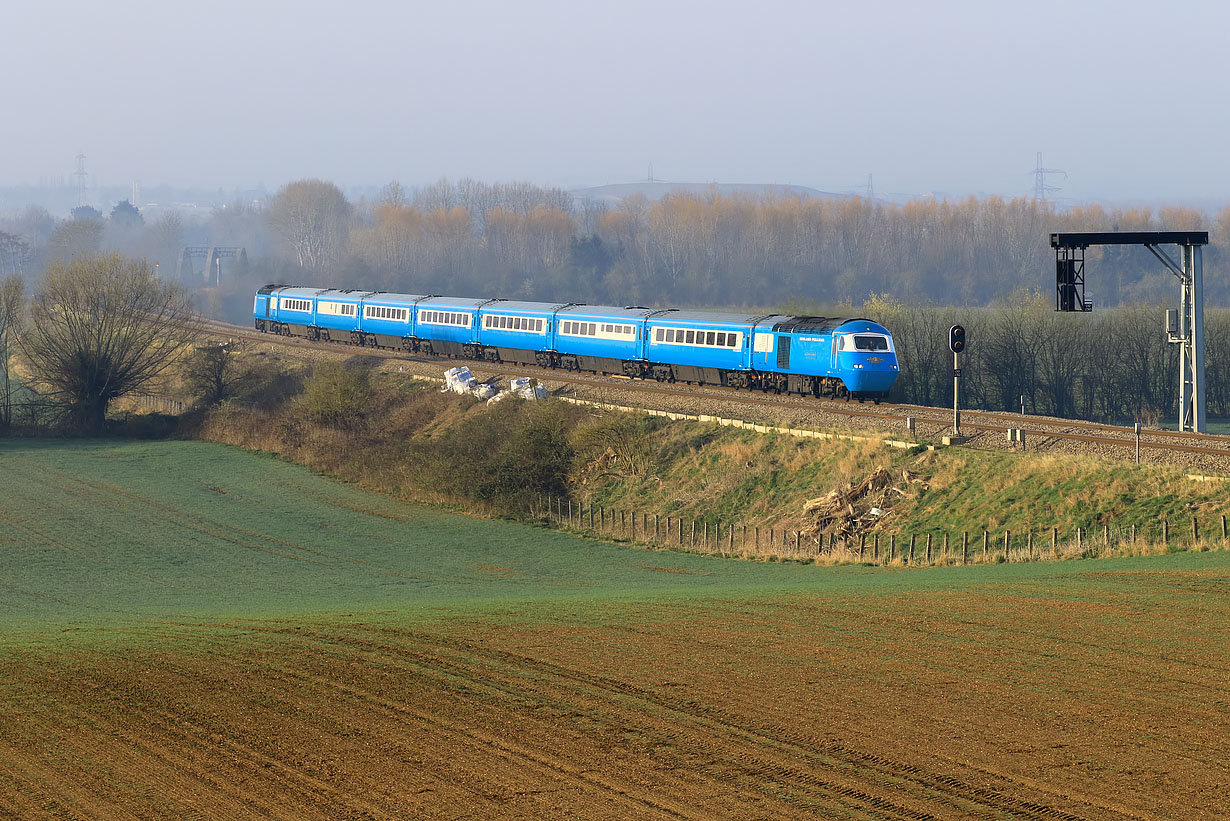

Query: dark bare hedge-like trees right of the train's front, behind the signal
<box><xmin>863</xmin><ymin>293</ymin><xmax>1230</xmax><ymax>423</ymax></box>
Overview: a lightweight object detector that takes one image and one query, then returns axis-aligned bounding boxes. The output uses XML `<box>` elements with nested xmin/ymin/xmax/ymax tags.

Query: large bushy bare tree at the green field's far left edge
<box><xmin>18</xmin><ymin>255</ymin><xmax>199</xmax><ymax>433</ymax></box>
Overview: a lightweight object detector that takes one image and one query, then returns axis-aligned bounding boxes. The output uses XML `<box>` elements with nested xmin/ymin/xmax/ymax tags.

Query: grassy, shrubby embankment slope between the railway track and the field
<box><xmin>186</xmin><ymin>359</ymin><xmax>1230</xmax><ymax>560</ymax></box>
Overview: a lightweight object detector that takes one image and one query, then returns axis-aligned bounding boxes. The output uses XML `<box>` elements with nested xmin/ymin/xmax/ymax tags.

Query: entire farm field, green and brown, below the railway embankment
<box><xmin>0</xmin><ymin>443</ymin><xmax>1230</xmax><ymax>819</ymax></box>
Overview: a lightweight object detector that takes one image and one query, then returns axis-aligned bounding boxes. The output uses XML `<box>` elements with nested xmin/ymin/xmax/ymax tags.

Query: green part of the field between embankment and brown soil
<box><xmin>0</xmin><ymin>441</ymin><xmax>1230</xmax><ymax>636</ymax></box>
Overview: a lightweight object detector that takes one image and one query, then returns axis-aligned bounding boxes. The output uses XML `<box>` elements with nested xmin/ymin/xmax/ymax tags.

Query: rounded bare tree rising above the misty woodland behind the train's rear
<box><xmin>268</xmin><ymin>180</ymin><xmax>351</xmax><ymax>270</ymax></box>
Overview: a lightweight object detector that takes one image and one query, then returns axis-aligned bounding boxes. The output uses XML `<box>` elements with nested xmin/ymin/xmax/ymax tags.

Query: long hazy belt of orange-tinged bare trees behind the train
<box><xmin>9</xmin><ymin>180</ymin><xmax>1230</xmax><ymax>315</ymax></box>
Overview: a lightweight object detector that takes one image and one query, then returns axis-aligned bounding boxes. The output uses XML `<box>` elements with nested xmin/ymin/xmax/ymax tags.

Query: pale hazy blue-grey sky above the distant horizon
<box><xmin>0</xmin><ymin>0</ymin><xmax>1230</xmax><ymax>202</ymax></box>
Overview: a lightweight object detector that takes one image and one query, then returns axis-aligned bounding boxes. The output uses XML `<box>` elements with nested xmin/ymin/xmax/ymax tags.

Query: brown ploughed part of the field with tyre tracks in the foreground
<box><xmin>0</xmin><ymin>568</ymin><xmax>1230</xmax><ymax>819</ymax></box>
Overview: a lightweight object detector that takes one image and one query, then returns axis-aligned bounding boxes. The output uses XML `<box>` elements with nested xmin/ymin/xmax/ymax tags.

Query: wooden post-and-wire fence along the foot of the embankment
<box><xmin>529</xmin><ymin>496</ymin><xmax>1230</xmax><ymax>566</ymax></box>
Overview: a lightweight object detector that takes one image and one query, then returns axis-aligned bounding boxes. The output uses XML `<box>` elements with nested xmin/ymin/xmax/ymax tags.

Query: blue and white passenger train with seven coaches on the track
<box><xmin>252</xmin><ymin>286</ymin><xmax>898</xmax><ymax>402</ymax></box>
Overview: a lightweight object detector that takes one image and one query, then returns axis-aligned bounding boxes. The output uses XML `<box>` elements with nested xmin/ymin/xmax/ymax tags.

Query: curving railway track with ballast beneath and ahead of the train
<box><xmin>208</xmin><ymin>321</ymin><xmax>1230</xmax><ymax>468</ymax></box>
